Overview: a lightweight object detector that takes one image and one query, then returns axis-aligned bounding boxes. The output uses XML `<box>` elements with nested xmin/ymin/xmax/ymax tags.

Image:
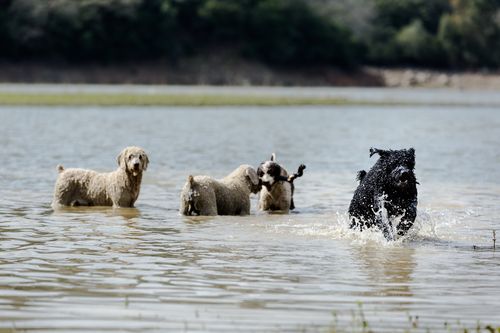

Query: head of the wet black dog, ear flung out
<box><xmin>370</xmin><ymin>148</ymin><xmax>418</xmax><ymax>188</ymax></box>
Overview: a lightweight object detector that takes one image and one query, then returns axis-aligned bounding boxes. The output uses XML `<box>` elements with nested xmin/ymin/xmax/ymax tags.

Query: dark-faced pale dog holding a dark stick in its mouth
<box><xmin>257</xmin><ymin>154</ymin><xmax>306</xmax><ymax>213</ymax></box>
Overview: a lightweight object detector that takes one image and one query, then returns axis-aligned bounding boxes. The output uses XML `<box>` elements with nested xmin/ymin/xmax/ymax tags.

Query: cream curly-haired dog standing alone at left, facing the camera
<box><xmin>52</xmin><ymin>147</ymin><xmax>149</xmax><ymax>208</ymax></box>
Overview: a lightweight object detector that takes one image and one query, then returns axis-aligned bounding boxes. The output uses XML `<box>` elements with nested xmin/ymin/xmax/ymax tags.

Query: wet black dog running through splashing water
<box><xmin>349</xmin><ymin>148</ymin><xmax>418</xmax><ymax>240</ymax></box>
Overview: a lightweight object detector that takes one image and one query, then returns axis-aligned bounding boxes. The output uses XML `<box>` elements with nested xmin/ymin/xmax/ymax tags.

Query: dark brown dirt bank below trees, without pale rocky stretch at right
<box><xmin>0</xmin><ymin>54</ymin><xmax>384</xmax><ymax>86</ymax></box>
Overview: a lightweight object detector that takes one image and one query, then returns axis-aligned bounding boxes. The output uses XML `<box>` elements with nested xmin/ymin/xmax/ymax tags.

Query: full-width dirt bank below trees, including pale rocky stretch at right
<box><xmin>0</xmin><ymin>54</ymin><xmax>500</xmax><ymax>90</ymax></box>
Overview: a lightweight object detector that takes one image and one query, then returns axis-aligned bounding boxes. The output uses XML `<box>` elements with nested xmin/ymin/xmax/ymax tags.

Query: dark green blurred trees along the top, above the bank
<box><xmin>0</xmin><ymin>0</ymin><xmax>500</xmax><ymax>69</ymax></box>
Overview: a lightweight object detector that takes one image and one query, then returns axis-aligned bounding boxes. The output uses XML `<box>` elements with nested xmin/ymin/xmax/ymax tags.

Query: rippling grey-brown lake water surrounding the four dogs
<box><xmin>0</xmin><ymin>90</ymin><xmax>500</xmax><ymax>332</ymax></box>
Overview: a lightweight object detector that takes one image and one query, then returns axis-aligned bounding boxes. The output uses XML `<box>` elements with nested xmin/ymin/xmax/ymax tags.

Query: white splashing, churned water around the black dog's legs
<box><xmin>247</xmin><ymin>208</ymin><xmax>490</xmax><ymax>247</ymax></box>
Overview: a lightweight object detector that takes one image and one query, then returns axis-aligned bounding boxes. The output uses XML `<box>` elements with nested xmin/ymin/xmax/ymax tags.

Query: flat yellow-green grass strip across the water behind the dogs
<box><xmin>0</xmin><ymin>92</ymin><xmax>352</xmax><ymax>106</ymax></box>
